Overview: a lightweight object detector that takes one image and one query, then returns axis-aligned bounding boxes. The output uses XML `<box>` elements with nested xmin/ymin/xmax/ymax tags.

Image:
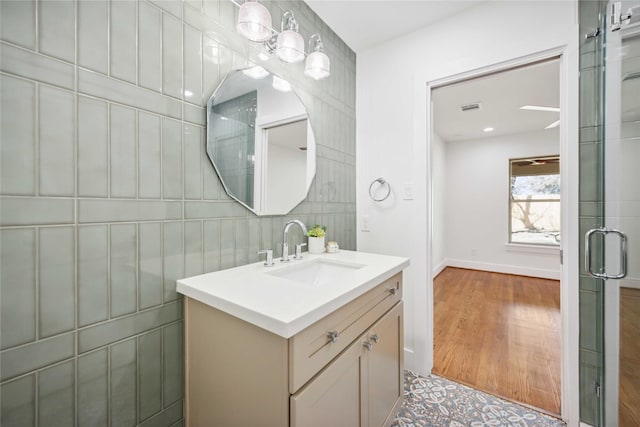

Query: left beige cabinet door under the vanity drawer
<box><xmin>290</xmin><ymin>339</ymin><xmax>366</xmax><ymax>427</ymax></box>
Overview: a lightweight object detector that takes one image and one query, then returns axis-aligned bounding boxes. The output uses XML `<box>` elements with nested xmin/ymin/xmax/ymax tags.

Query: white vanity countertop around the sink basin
<box><xmin>177</xmin><ymin>250</ymin><xmax>409</xmax><ymax>338</ymax></box>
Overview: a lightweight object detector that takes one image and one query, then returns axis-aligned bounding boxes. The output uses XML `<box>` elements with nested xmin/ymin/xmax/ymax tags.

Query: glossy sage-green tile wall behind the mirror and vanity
<box><xmin>0</xmin><ymin>0</ymin><xmax>356</xmax><ymax>427</ymax></box>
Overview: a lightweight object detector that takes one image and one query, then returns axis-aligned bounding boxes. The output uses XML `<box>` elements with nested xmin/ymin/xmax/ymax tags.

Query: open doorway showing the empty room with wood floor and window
<box><xmin>430</xmin><ymin>56</ymin><xmax>562</xmax><ymax>416</ymax></box>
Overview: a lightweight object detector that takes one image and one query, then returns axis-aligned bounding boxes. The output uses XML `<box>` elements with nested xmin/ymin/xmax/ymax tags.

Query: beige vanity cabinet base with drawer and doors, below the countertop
<box><xmin>185</xmin><ymin>272</ymin><xmax>404</xmax><ymax>427</ymax></box>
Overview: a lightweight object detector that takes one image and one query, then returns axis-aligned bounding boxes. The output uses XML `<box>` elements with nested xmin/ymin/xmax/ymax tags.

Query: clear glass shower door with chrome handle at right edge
<box><xmin>585</xmin><ymin>0</ymin><xmax>640</xmax><ymax>427</ymax></box>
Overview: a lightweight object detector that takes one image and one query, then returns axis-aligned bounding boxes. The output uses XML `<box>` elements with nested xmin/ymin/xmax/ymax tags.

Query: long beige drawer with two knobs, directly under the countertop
<box><xmin>289</xmin><ymin>273</ymin><xmax>402</xmax><ymax>394</ymax></box>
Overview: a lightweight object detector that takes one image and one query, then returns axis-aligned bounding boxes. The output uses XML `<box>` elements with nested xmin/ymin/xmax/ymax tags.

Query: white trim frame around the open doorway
<box><xmin>421</xmin><ymin>45</ymin><xmax>580</xmax><ymax>426</ymax></box>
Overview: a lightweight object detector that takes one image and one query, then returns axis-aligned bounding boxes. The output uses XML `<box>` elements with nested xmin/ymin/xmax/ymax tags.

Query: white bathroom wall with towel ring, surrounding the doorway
<box><xmin>356</xmin><ymin>1</ymin><xmax>578</xmax><ymax>419</ymax></box>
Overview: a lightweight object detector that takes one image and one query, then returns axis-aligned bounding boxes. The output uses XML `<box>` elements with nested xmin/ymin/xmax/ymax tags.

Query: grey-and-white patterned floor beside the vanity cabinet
<box><xmin>391</xmin><ymin>371</ymin><xmax>565</xmax><ymax>427</ymax></box>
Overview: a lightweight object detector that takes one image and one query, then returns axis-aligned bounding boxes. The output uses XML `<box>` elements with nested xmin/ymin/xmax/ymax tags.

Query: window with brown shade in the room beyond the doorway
<box><xmin>509</xmin><ymin>156</ymin><xmax>560</xmax><ymax>246</ymax></box>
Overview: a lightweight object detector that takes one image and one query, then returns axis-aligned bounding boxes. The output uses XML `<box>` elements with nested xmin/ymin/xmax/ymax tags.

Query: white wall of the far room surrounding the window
<box><xmin>444</xmin><ymin>128</ymin><xmax>560</xmax><ymax>279</ymax></box>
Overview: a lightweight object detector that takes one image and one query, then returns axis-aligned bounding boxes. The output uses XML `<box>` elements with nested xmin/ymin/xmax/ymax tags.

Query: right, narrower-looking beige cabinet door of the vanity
<box><xmin>366</xmin><ymin>303</ymin><xmax>404</xmax><ymax>427</ymax></box>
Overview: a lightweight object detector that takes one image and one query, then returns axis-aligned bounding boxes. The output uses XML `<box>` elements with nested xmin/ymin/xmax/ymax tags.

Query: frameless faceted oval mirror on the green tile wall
<box><xmin>207</xmin><ymin>66</ymin><xmax>316</xmax><ymax>215</ymax></box>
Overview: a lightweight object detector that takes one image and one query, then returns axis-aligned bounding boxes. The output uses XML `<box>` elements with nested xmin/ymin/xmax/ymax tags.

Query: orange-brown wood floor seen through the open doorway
<box><xmin>433</xmin><ymin>267</ymin><xmax>561</xmax><ymax>414</ymax></box>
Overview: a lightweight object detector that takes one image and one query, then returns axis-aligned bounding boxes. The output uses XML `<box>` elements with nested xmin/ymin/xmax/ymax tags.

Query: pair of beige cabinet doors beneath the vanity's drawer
<box><xmin>290</xmin><ymin>302</ymin><xmax>403</xmax><ymax>427</ymax></box>
